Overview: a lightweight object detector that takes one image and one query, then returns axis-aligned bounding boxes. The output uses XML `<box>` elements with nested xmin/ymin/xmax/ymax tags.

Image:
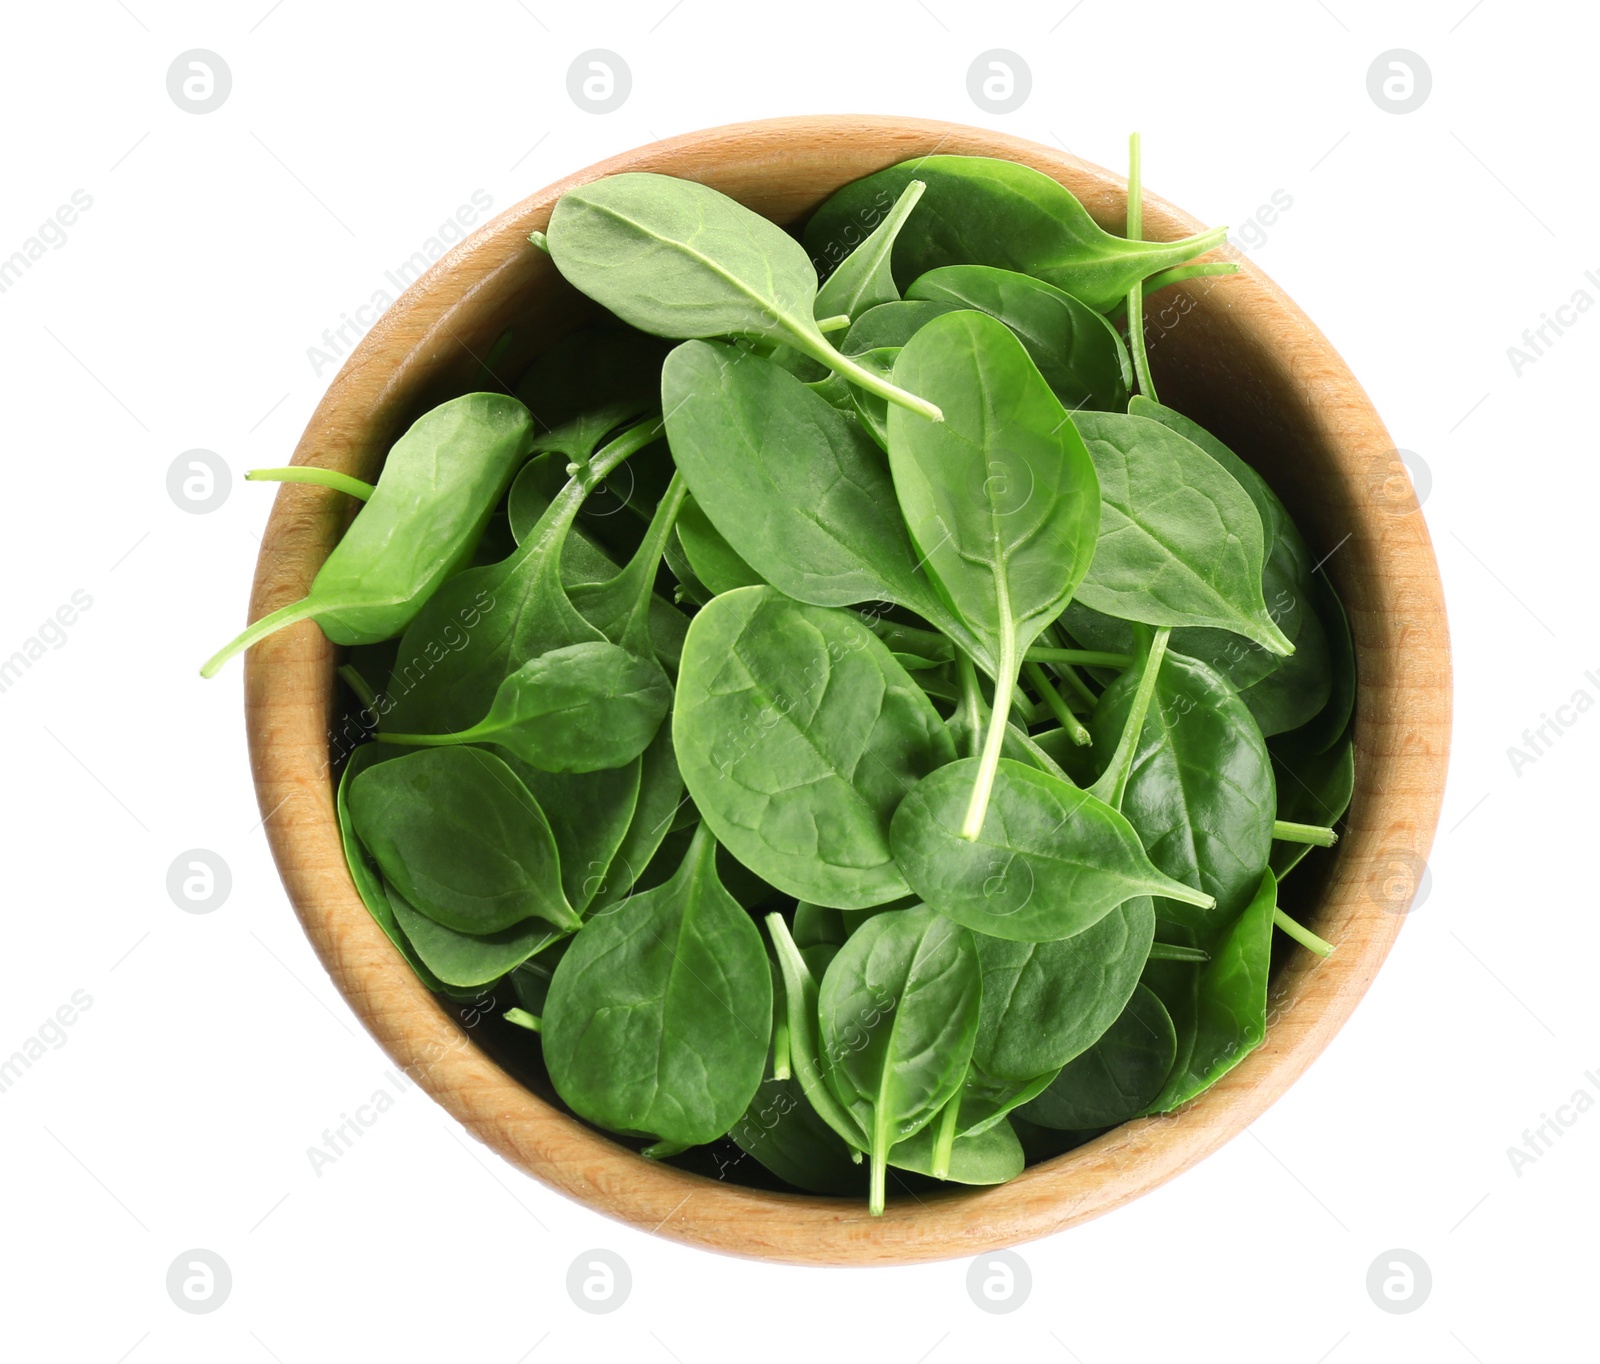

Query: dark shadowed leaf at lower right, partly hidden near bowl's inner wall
<box><xmin>1021</xmin><ymin>985</ymin><xmax>1178</xmax><ymax>1130</ymax></box>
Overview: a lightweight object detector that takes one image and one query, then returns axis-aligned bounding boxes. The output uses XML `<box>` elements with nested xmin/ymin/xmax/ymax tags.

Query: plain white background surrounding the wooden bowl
<box><xmin>0</xmin><ymin>0</ymin><xmax>1600</xmax><ymax>1364</ymax></box>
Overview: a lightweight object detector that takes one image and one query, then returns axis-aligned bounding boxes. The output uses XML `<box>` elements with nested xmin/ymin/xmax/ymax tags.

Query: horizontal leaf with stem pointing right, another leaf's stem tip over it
<box><xmin>890</xmin><ymin>757</ymin><xmax>1211</xmax><ymax>943</ymax></box>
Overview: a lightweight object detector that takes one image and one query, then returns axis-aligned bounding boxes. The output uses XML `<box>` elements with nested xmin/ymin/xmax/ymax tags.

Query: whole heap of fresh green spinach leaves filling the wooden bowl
<box><xmin>205</xmin><ymin>144</ymin><xmax>1355</xmax><ymax>1212</ymax></box>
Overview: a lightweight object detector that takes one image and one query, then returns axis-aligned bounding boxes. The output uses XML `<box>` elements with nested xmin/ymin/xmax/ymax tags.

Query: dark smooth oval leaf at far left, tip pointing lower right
<box><xmin>349</xmin><ymin>748</ymin><xmax>578</xmax><ymax>933</ymax></box>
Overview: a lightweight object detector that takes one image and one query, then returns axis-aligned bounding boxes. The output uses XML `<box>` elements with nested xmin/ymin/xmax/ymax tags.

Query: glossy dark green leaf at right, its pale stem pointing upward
<box><xmin>1090</xmin><ymin>652</ymin><xmax>1277</xmax><ymax>932</ymax></box>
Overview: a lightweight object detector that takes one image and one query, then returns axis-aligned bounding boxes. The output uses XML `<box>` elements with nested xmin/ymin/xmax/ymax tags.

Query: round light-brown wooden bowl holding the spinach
<box><xmin>245</xmin><ymin>117</ymin><xmax>1450</xmax><ymax>1265</ymax></box>
